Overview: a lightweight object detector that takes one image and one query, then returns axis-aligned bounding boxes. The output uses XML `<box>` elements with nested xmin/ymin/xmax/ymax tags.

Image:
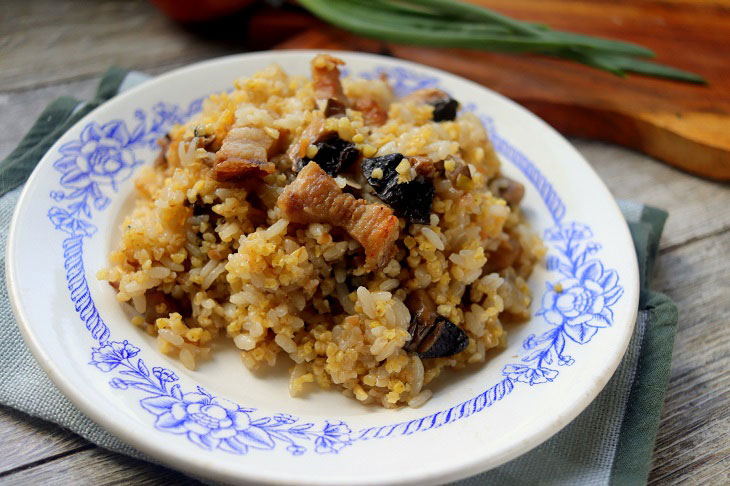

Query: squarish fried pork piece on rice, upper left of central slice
<box><xmin>213</xmin><ymin>127</ymin><xmax>281</xmax><ymax>182</ymax></box>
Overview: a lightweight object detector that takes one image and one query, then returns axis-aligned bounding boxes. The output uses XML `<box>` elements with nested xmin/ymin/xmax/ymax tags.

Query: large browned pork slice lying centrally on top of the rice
<box><xmin>276</xmin><ymin>162</ymin><xmax>399</xmax><ymax>270</ymax></box>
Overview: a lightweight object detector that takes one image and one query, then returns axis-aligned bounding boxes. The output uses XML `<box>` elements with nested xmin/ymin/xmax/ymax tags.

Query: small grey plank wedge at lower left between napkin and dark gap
<box><xmin>0</xmin><ymin>406</ymin><xmax>89</xmax><ymax>475</ymax></box>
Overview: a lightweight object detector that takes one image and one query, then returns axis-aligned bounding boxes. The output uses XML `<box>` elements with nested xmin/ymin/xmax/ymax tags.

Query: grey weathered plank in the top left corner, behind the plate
<box><xmin>0</xmin><ymin>0</ymin><xmax>229</xmax><ymax>91</ymax></box>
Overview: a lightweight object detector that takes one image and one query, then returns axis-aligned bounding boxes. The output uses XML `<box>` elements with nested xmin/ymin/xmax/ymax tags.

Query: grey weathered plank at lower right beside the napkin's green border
<box><xmin>650</xmin><ymin>232</ymin><xmax>730</xmax><ymax>484</ymax></box>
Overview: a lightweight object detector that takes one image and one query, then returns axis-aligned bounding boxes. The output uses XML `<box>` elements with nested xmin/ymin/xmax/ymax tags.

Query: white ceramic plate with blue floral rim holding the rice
<box><xmin>7</xmin><ymin>51</ymin><xmax>638</xmax><ymax>485</ymax></box>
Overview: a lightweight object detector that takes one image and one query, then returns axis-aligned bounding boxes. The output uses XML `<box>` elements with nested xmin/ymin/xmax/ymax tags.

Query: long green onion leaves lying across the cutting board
<box><xmin>299</xmin><ymin>0</ymin><xmax>705</xmax><ymax>83</ymax></box>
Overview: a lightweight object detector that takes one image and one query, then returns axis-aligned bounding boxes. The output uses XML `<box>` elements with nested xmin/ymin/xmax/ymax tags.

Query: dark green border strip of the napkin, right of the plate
<box><xmin>610</xmin><ymin>292</ymin><xmax>677</xmax><ymax>486</ymax></box>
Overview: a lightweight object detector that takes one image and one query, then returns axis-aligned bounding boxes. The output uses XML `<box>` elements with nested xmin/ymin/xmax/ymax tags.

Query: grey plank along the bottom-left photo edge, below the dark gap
<box><xmin>0</xmin><ymin>448</ymin><xmax>202</xmax><ymax>486</ymax></box>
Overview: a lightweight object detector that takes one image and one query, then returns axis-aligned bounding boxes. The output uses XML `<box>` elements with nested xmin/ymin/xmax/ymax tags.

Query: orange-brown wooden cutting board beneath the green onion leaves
<box><xmin>277</xmin><ymin>0</ymin><xmax>730</xmax><ymax>181</ymax></box>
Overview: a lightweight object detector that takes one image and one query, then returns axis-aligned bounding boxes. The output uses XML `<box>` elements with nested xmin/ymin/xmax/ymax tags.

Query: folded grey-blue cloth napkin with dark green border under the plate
<box><xmin>0</xmin><ymin>68</ymin><xmax>677</xmax><ymax>486</ymax></box>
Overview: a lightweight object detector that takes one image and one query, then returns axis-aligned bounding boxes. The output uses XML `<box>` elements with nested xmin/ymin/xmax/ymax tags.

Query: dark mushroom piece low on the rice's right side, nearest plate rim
<box><xmin>404</xmin><ymin>289</ymin><xmax>469</xmax><ymax>358</ymax></box>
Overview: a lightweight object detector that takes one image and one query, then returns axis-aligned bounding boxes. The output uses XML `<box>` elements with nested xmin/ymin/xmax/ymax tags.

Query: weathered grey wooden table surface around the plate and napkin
<box><xmin>0</xmin><ymin>0</ymin><xmax>730</xmax><ymax>485</ymax></box>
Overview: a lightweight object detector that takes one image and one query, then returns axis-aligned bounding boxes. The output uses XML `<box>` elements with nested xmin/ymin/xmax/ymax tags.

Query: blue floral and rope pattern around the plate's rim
<box><xmin>48</xmin><ymin>63</ymin><xmax>623</xmax><ymax>456</ymax></box>
